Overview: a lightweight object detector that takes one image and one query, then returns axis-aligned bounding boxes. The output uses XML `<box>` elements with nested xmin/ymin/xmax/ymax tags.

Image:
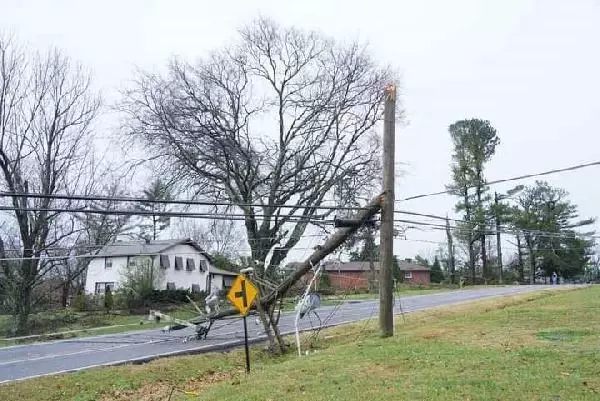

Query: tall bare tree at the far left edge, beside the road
<box><xmin>0</xmin><ymin>35</ymin><xmax>100</xmax><ymax>333</ymax></box>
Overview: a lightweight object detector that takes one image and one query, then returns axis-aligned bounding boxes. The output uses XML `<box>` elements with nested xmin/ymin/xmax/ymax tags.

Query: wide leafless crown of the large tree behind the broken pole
<box><xmin>123</xmin><ymin>19</ymin><xmax>393</xmax><ymax>276</ymax></box>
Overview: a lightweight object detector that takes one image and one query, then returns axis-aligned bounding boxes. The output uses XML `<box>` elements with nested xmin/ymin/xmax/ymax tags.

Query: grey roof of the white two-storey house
<box><xmin>89</xmin><ymin>238</ymin><xmax>211</xmax><ymax>260</ymax></box>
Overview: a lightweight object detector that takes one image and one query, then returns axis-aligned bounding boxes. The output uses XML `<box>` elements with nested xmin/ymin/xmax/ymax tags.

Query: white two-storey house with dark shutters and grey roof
<box><xmin>85</xmin><ymin>239</ymin><xmax>236</xmax><ymax>294</ymax></box>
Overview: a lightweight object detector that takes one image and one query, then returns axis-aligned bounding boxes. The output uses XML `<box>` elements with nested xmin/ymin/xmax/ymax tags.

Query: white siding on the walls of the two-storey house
<box><xmin>85</xmin><ymin>245</ymin><xmax>216</xmax><ymax>293</ymax></box>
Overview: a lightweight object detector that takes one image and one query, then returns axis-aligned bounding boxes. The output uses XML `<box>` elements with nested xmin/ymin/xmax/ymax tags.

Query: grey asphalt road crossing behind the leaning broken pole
<box><xmin>0</xmin><ymin>286</ymin><xmax>564</xmax><ymax>383</ymax></box>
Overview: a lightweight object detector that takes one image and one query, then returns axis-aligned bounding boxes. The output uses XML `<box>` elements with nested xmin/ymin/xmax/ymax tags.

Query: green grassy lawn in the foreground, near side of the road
<box><xmin>0</xmin><ymin>286</ymin><xmax>600</xmax><ymax>401</ymax></box>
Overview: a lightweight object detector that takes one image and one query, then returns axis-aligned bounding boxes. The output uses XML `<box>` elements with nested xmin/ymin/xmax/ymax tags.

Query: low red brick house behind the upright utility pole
<box><xmin>314</xmin><ymin>259</ymin><xmax>430</xmax><ymax>290</ymax></box>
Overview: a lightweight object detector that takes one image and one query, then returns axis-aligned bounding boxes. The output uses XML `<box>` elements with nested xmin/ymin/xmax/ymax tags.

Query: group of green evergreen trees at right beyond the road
<box><xmin>443</xmin><ymin>119</ymin><xmax>595</xmax><ymax>283</ymax></box>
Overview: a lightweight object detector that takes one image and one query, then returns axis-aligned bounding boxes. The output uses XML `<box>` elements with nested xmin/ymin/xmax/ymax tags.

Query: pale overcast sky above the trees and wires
<box><xmin>0</xmin><ymin>0</ymin><xmax>600</xmax><ymax>257</ymax></box>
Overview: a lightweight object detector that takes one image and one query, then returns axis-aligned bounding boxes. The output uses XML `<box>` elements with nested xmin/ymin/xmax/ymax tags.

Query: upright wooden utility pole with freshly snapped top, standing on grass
<box><xmin>379</xmin><ymin>84</ymin><xmax>396</xmax><ymax>337</ymax></box>
